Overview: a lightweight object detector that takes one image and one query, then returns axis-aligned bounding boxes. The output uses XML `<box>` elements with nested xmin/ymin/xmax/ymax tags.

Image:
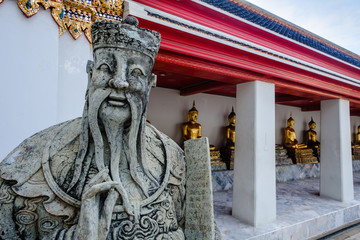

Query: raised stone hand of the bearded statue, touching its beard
<box><xmin>74</xmin><ymin>181</ymin><xmax>119</xmax><ymax>240</ymax></box>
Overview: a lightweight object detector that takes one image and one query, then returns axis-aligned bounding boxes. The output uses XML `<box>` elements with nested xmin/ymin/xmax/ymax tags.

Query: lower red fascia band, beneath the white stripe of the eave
<box><xmin>137</xmin><ymin>17</ymin><xmax>360</xmax><ymax>98</ymax></box>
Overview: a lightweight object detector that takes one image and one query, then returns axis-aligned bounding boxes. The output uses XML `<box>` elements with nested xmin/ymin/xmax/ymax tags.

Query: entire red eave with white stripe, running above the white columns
<box><xmin>129</xmin><ymin>0</ymin><xmax>360</xmax><ymax>114</ymax></box>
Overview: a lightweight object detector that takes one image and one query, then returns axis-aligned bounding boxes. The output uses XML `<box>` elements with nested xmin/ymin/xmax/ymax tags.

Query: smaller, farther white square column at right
<box><xmin>320</xmin><ymin>99</ymin><xmax>354</xmax><ymax>201</ymax></box>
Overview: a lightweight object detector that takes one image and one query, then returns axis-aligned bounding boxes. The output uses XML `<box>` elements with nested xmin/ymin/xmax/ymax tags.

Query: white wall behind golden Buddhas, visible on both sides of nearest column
<box><xmin>148</xmin><ymin>88</ymin><xmax>326</xmax><ymax>148</ymax></box>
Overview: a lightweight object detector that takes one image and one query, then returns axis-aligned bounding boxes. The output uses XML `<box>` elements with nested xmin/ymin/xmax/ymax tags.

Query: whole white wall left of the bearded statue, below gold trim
<box><xmin>0</xmin><ymin>1</ymin><xmax>92</xmax><ymax>160</ymax></box>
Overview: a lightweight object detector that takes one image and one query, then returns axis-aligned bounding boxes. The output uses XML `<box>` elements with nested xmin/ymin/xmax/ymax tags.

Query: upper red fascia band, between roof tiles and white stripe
<box><xmin>136</xmin><ymin>0</ymin><xmax>360</xmax><ymax>80</ymax></box>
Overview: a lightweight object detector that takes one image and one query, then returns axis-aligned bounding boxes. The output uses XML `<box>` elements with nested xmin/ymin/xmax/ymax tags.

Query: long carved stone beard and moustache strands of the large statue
<box><xmin>68</xmin><ymin>85</ymin><xmax>159</xmax><ymax>202</ymax></box>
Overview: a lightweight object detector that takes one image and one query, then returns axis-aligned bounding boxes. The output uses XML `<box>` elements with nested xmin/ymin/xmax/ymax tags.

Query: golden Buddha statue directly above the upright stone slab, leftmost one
<box><xmin>182</xmin><ymin>101</ymin><xmax>201</xmax><ymax>141</ymax></box>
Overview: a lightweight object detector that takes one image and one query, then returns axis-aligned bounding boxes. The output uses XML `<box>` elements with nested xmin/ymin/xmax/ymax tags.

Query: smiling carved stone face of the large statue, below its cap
<box><xmin>89</xmin><ymin>48</ymin><xmax>153</xmax><ymax>123</ymax></box>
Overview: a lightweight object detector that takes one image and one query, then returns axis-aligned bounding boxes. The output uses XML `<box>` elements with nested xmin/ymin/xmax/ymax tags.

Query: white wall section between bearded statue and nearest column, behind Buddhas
<box><xmin>147</xmin><ymin>87</ymin><xmax>235</xmax><ymax>148</ymax></box>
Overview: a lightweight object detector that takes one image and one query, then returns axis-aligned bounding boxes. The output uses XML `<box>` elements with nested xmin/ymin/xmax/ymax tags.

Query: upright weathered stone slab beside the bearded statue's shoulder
<box><xmin>184</xmin><ymin>137</ymin><xmax>215</xmax><ymax>240</ymax></box>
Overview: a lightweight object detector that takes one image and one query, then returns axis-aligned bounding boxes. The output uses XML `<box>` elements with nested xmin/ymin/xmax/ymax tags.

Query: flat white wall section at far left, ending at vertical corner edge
<box><xmin>0</xmin><ymin>1</ymin><xmax>59</xmax><ymax>160</ymax></box>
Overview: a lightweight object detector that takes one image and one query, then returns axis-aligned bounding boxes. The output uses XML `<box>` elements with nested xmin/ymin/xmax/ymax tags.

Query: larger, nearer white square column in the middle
<box><xmin>232</xmin><ymin>81</ymin><xmax>276</xmax><ymax>226</ymax></box>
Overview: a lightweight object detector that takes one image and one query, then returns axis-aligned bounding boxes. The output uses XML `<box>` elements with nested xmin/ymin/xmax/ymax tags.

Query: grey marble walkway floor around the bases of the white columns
<box><xmin>214</xmin><ymin>172</ymin><xmax>360</xmax><ymax>240</ymax></box>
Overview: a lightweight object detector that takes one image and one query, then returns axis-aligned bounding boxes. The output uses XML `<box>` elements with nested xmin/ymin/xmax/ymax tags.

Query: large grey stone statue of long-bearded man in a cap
<box><xmin>0</xmin><ymin>17</ymin><xmax>219</xmax><ymax>240</ymax></box>
